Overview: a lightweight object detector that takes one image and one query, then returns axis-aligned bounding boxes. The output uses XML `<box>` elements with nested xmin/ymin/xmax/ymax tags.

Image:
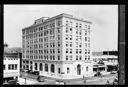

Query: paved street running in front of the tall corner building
<box><xmin>21</xmin><ymin>73</ymin><xmax>117</xmax><ymax>85</ymax></box>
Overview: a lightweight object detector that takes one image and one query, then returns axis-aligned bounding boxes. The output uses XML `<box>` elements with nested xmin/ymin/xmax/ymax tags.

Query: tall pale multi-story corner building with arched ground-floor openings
<box><xmin>22</xmin><ymin>14</ymin><xmax>93</xmax><ymax>79</ymax></box>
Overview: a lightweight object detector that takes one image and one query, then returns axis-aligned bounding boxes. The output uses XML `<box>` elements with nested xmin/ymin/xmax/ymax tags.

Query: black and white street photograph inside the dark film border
<box><xmin>3</xmin><ymin>4</ymin><xmax>119</xmax><ymax>85</ymax></box>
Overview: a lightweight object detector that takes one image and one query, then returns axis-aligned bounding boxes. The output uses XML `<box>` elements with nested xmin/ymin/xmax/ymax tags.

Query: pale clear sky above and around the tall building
<box><xmin>3</xmin><ymin>4</ymin><xmax>118</xmax><ymax>51</ymax></box>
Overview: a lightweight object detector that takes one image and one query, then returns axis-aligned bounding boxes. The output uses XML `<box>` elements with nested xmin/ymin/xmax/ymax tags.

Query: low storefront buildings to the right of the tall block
<box><xmin>92</xmin><ymin>52</ymin><xmax>118</xmax><ymax>74</ymax></box>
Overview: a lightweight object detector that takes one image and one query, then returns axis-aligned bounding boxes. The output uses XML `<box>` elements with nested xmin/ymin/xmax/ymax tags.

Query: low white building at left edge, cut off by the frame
<box><xmin>3</xmin><ymin>44</ymin><xmax>20</xmax><ymax>82</ymax></box>
